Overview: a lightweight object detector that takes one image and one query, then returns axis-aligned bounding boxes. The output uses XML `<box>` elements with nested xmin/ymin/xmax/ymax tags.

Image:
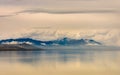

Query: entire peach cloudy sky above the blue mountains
<box><xmin>0</xmin><ymin>0</ymin><xmax>120</xmax><ymax>44</ymax></box>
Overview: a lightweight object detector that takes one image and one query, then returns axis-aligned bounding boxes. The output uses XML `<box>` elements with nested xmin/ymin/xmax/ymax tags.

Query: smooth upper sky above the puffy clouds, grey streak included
<box><xmin>0</xmin><ymin>0</ymin><xmax>120</xmax><ymax>32</ymax></box>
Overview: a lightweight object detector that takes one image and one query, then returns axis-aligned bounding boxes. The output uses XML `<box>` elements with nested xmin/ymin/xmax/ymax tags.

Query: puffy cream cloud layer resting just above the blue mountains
<box><xmin>1</xmin><ymin>30</ymin><xmax>120</xmax><ymax>46</ymax></box>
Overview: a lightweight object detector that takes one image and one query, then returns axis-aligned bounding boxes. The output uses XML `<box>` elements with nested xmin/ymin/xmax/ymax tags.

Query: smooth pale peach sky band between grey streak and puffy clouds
<box><xmin>0</xmin><ymin>13</ymin><xmax>120</xmax><ymax>32</ymax></box>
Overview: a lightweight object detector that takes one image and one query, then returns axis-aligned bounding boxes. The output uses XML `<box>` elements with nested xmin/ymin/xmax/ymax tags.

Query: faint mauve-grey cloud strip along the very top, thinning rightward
<box><xmin>0</xmin><ymin>0</ymin><xmax>96</xmax><ymax>6</ymax></box>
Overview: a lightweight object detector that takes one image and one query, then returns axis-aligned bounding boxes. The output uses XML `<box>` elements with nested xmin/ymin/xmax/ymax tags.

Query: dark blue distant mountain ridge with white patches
<box><xmin>0</xmin><ymin>37</ymin><xmax>102</xmax><ymax>46</ymax></box>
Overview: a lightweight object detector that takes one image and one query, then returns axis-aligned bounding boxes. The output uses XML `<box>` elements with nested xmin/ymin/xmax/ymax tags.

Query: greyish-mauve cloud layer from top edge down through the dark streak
<box><xmin>0</xmin><ymin>0</ymin><xmax>120</xmax><ymax>17</ymax></box>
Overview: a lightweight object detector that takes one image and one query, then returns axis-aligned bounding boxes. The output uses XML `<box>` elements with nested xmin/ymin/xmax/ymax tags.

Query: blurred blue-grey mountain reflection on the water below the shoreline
<box><xmin>0</xmin><ymin>50</ymin><xmax>120</xmax><ymax>64</ymax></box>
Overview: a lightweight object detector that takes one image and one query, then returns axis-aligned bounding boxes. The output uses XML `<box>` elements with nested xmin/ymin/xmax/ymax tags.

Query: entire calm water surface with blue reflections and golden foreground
<box><xmin>0</xmin><ymin>50</ymin><xmax>120</xmax><ymax>75</ymax></box>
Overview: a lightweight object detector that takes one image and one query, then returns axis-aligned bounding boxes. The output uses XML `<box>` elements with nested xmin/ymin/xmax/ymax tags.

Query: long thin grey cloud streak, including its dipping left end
<box><xmin>0</xmin><ymin>9</ymin><xmax>118</xmax><ymax>17</ymax></box>
